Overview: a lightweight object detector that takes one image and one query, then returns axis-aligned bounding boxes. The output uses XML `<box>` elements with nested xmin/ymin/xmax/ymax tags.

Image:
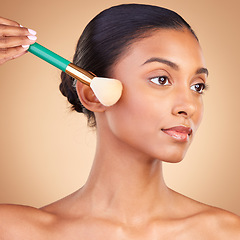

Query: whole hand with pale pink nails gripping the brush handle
<box><xmin>0</xmin><ymin>17</ymin><xmax>37</xmax><ymax>65</ymax></box>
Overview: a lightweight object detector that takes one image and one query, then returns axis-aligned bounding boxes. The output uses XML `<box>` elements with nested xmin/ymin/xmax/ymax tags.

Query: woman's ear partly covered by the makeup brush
<box><xmin>76</xmin><ymin>81</ymin><xmax>107</xmax><ymax>112</ymax></box>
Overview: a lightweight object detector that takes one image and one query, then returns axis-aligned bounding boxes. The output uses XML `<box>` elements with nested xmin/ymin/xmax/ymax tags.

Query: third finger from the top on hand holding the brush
<box><xmin>0</xmin><ymin>36</ymin><xmax>37</xmax><ymax>49</ymax></box>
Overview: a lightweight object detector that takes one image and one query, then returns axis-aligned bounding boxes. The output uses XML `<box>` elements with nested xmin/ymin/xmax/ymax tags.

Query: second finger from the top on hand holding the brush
<box><xmin>0</xmin><ymin>24</ymin><xmax>36</xmax><ymax>37</ymax></box>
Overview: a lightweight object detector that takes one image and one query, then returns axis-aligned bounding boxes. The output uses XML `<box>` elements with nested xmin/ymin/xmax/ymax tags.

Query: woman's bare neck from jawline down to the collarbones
<box><xmin>78</xmin><ymin>126</ymin><xmax>170</xmax><ymax>223</ymax></box>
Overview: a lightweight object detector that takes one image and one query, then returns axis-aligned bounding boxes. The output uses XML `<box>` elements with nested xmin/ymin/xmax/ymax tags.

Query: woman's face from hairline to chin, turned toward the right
<box><xmin>102</xmin><ymin>29</ymin><xmax>207</xmax><ymax>162</ymax></box>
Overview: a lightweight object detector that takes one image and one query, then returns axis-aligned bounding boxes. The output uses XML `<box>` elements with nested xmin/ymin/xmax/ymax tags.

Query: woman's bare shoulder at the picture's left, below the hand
<box><xmin>0</xmin><ymin>204</ymin><xmax>55</xmax><ymax>240</ymax></box>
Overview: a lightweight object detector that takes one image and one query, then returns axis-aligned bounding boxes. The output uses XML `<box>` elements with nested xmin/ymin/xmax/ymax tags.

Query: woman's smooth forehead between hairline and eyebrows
<box><xmin>111</xmin><ymin>29</ymin><xmax>205</xmax><ymax>73</ymax></box>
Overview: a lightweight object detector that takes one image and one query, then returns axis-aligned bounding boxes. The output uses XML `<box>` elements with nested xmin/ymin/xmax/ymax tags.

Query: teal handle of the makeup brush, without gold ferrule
<box><xmin>28</xmin><ymin>42</ymin><xmax>71</xmax><ymax>72</ymax></box>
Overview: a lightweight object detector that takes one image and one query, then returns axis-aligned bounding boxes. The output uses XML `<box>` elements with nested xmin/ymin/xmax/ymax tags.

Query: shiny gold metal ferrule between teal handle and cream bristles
<box><xmin>65</xmin><ymin>63</ymin><xmax>96</xmax><ymax>86</ymax></box>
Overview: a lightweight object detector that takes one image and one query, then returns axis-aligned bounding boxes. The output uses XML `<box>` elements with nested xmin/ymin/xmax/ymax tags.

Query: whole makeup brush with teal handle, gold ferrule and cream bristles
<box><xmin>28</xmin><ymin>42</ymin><xmax>122</xmax><ymax>106</ymax></box>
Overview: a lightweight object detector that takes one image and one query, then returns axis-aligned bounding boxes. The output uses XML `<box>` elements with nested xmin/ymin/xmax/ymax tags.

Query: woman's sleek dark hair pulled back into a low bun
<box><xmin>60</xmin><ymin>4</ymin><xmax>197</xmax><ymax>126</ymax></box>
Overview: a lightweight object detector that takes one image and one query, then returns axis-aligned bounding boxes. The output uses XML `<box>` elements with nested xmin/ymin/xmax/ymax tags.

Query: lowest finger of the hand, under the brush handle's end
<box><xmin>0</xmin><ymin>46</ymin><xmax>27</xmax><ymax>64</ymax></box>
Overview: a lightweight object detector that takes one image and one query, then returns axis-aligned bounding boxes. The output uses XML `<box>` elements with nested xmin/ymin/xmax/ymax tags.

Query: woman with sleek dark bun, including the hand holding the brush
<box><xmin>0</xmin><ymin>4</ymin><xmax>240</xmax><ymax>240</ymax></box>
